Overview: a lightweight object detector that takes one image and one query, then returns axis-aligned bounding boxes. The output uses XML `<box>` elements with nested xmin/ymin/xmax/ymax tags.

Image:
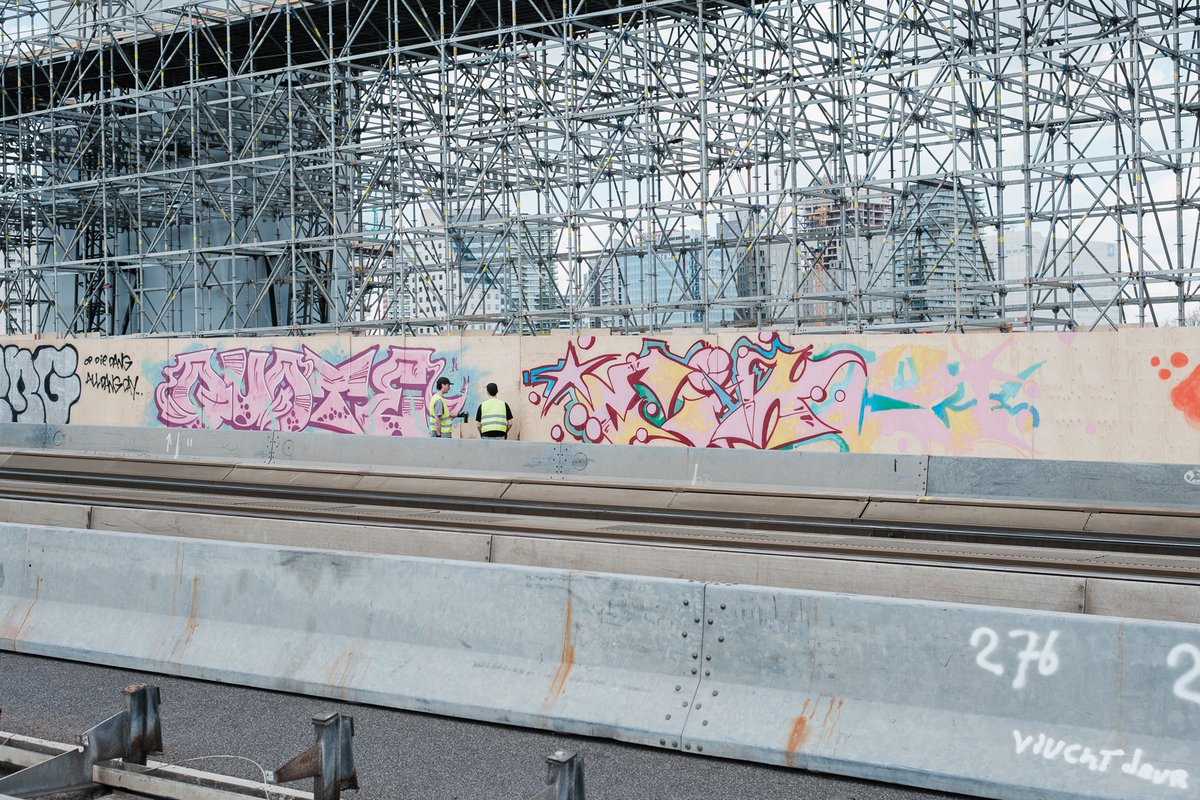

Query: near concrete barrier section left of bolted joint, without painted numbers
<box><xmin>0</xmin><ymin>525</ymin><xmax>703</xmax><ymax>745</ymax></box>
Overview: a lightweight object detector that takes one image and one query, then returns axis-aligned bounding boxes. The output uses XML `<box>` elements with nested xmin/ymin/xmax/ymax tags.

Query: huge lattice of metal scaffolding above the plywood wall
<box><xmin>0</xmin><ymin>0</ymin><xmax>1200</xmax><ymax>336</ymax></box>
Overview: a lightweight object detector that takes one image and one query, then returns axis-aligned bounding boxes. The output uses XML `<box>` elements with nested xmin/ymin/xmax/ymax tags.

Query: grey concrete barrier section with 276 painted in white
<box><xmin>684</xmin><ymin>584</ymin><xmax>1200</xmax><ymax>800</ymax></box>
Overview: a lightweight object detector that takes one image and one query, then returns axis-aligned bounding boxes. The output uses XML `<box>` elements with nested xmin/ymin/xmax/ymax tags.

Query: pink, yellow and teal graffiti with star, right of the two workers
<box><xmin>522</xmin><ymin>332</ymin><xmax>1042</xmax><ymax>452</ymax></box>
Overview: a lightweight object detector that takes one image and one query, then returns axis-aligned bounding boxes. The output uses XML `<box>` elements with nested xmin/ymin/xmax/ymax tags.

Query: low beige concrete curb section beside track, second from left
<box><xmin>92</xmin><ymin>509</ymin><xmax>490</xmax><ymax>561</ymax></box>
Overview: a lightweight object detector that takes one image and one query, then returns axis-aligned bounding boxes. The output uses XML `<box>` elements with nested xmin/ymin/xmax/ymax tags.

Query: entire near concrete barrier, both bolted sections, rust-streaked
<box><xmin>0</xmin><ymin>524</ymin><xmax>1200</xmax><ymax>800</ymax></box>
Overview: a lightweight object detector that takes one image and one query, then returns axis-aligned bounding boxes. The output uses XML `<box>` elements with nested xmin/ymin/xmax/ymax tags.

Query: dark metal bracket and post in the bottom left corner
<box><xmin>0</xmin><ymin>684</ymin><xmax>162</xmax><ymax>798</ymax></box>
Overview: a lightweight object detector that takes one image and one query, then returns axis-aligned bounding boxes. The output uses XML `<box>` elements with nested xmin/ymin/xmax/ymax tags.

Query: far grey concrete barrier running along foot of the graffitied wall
<box><xmin>0</xmin><ymin>423</ymin><xmax>1200</xmax><ymax>515</ymax></box>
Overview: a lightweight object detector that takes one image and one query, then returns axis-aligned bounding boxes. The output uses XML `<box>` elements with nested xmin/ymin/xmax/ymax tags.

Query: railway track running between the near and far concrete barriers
<box><xmin>0</xmin><ymin>455</ymin><xmax>1200</xmax><ymax>585</ymax></box>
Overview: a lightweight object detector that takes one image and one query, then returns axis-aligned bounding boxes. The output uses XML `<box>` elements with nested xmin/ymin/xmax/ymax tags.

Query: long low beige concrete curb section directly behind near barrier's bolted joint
<box><xmin>492</xmin><ymin>535</ymin><xmax>1084</xmax><ymax>612</ymax></box>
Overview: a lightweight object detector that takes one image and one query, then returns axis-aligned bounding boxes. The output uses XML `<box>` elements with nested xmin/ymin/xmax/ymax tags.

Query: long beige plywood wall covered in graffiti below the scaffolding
<box><xmin>6</xmin><ymin>327</ymin><xmax>1200</xmax><ymax>468</ymax></box>
